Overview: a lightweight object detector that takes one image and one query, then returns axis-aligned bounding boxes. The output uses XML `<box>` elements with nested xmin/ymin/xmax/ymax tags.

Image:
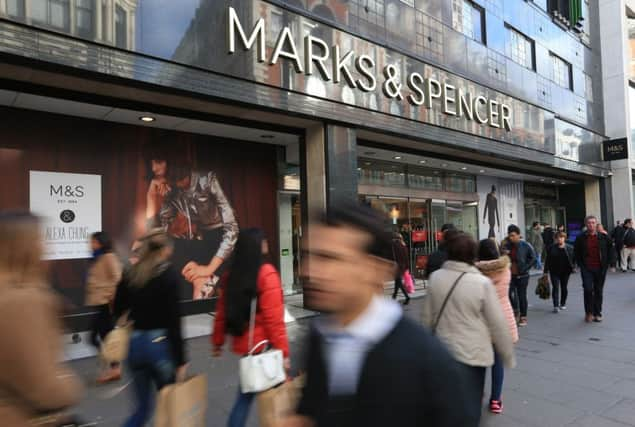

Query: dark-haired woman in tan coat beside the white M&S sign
<box><xmin>86</xmin><ymin>231</ymin><xmax>121</xmax><ymax>383</ymax></box>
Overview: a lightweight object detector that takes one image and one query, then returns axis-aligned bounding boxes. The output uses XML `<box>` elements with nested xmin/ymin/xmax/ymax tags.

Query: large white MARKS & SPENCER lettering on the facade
<box><xmin>227</xmin><ymin>6</ymin><xmax>512</xmax><ymax>132</ymax></box>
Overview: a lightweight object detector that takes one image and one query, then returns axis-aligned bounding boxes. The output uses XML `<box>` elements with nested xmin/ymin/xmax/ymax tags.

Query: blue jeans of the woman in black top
<box><xmin>124</xmin><ymin>329</ymin><xmax>176</xmax><ymax>427</ymax></box>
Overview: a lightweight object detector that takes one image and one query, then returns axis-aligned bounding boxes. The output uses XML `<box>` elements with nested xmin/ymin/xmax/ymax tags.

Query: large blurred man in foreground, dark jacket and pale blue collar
<box><xmin>292</xmin><ymin>204</ymin><xmax>477</xmax><ymax>427</ymax></box>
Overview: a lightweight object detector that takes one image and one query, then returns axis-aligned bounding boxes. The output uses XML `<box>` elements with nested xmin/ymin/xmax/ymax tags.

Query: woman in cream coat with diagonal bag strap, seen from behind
<box><xmin>423</xmin><ymin>233</ymin><xmax>515</xmax><ymax>425</ymax></box>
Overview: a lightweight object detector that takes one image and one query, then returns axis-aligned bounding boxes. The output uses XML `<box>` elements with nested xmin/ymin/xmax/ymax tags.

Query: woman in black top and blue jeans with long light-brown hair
<box><xmin>115</xmin><ymin>230</ymin><xmax>186</xmax><ymax>427</ymax></box>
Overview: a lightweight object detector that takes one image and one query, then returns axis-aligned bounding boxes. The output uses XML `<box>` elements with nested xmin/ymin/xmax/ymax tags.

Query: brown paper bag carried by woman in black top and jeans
<box><xmin>154</xmin><ymin>374</ymin><xmax>207</xmax><ymax>427</ymax></box>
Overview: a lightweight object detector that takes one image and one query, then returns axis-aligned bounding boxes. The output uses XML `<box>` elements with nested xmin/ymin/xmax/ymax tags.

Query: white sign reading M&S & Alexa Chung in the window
<box><xmin>29</xmin><ymin>171</ymin><xmax>101</xmax><ymax>260</ymax></box>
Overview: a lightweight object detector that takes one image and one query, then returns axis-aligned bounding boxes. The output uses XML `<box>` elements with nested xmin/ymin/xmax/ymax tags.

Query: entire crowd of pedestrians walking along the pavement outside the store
<box><xmin>0</xmin><ymin>203</ymin><xmax>624</xmax><ymax>427</ymax></box>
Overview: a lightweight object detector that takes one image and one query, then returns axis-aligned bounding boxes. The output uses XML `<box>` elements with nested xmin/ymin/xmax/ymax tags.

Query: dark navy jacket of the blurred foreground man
<box><xmin>298</xmin><ymin>317</ymin><xmax>476</xmax><ymax>427</ymax></box>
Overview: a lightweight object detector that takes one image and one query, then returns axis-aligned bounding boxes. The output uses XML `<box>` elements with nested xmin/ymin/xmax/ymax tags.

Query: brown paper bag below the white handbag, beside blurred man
<box><xmin>256</xmin><ymin>376</ymin><xmax>304</xmax><ymax>427</ymax></box>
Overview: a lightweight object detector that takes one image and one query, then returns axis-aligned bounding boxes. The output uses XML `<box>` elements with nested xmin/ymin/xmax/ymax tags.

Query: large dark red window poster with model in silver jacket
<box><xmin>0</xmin><ymin>106</ymin><xmax>279</xmax><ymax>312</ymax></box>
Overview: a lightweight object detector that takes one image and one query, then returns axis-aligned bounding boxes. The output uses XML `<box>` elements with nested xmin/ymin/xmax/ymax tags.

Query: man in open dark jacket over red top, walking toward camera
<box><xmin>574</xmin><ymin>215</ymin><xmax>615</xmax><ymax>323</ymax></box>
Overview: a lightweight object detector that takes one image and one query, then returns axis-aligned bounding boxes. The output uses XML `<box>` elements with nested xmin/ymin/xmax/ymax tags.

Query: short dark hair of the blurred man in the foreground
<box><xmin>322</xmin><ymin>201</ymin><xmax>393</xmax><ymax>261</ymax></box>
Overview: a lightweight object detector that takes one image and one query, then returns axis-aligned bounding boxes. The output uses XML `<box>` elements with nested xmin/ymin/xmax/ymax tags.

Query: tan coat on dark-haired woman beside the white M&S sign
<box><xmin>86</xmin><ymin>253</ymin><xmax>121</xmax><ymax>306</ymax></box>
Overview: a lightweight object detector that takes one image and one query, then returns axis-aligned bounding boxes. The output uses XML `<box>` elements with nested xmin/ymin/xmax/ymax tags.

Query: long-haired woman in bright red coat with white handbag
<box><xmin>212</xmin><ymin>229</ymin><xmax>289</xmax><ymax>427</ymax></box>
